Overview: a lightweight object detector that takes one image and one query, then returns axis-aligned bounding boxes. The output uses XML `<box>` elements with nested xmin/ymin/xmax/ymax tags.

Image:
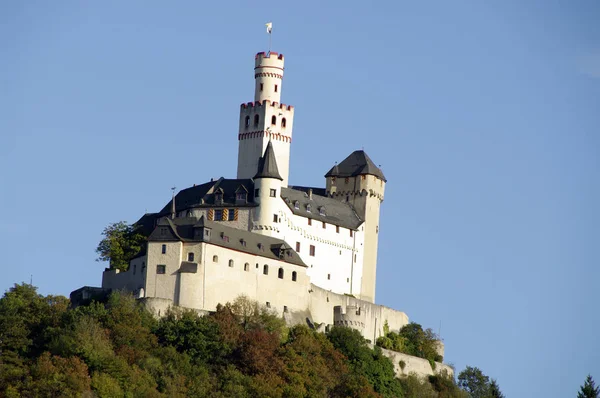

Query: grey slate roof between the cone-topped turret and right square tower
<box><xmin>281</xmin><ymin>187</ymin><xmax>363</xmax><ymax>230</ymax></box>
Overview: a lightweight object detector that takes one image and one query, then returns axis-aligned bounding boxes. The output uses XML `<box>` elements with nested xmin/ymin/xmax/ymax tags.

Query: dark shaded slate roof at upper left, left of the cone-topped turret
<box><xmin>158</xmin><ymin>177</ymin><xmax>256</xmax><ymax>216</ymax></box>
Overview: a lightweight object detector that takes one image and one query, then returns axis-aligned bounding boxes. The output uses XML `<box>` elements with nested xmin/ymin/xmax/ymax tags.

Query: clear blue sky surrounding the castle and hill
<box><xmin>0</xmin><ymin>0</ymin><xmax>600</xmax><ymax>398</ymax></box>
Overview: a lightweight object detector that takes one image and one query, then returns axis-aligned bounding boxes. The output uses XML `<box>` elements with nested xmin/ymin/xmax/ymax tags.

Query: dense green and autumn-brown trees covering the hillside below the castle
<box><xmin>0</xmin><ymin>284</ymin><xmax>502</xmax><ymax>398</ymax></box>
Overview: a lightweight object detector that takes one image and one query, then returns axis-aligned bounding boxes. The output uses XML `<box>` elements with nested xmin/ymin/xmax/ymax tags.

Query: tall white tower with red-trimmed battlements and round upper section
<box><xmin>237</xmin><ymin>52</ymin><xmax>294</xmax><ymax>187</ymax></box>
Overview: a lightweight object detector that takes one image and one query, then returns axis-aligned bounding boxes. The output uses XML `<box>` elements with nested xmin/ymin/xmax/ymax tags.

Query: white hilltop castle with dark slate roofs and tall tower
<box><xmin>73</xmin><ymin>52</ymin><xmax>452</xmax><ymax>376</ymax></box>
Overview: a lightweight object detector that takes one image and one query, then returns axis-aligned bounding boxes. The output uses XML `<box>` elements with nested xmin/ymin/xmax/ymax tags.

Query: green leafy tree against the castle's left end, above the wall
<box><xmin>96</xmin><ymin>221</ymin><xmax>146</xmax><ymax>271</ymax></box>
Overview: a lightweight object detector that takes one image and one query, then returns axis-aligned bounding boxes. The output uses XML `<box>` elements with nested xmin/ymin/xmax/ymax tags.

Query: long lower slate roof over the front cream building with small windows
<box><xmin>148</xmin><ymin>217</ymin><xmax>306</xmax><ymax>267</ymax></box>
